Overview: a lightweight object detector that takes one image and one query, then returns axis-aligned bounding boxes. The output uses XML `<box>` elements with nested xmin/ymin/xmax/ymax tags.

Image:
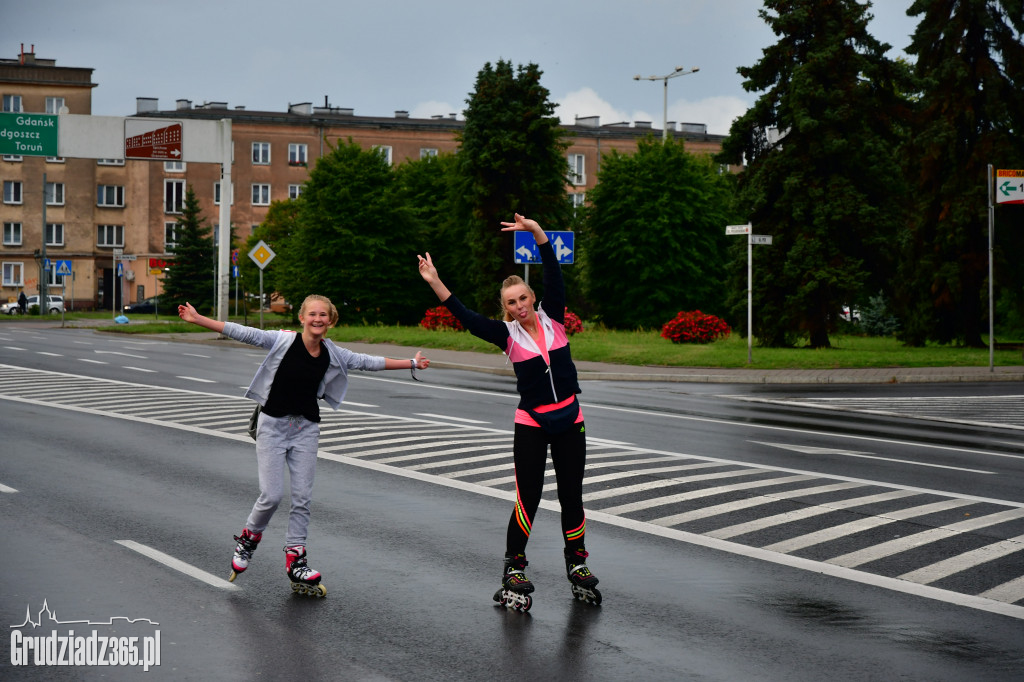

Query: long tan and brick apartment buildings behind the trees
<box><xmin>0</xmin><ymin>49</ymin><xmax>723</xmax><ymax>309</ymax></box>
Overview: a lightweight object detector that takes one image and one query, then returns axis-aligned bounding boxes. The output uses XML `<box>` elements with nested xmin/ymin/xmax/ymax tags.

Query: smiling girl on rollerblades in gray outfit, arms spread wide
<box><xmin>178</xmin><ymin>295</ymin><xmax>430</xmax><ymax>597</ymax></box>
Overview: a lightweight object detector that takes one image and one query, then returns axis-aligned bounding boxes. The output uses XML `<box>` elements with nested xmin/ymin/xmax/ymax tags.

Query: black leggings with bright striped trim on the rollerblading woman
<box><xmin>505</xmin><ymin>422</ymin><xmax>587</xmax><ymax>554</ymax></box>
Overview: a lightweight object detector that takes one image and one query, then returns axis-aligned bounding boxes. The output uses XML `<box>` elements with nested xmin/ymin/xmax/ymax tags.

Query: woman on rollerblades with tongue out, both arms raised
<box><xmin>419</xmin><ymin>214</ymin><xmax>601</xmax><ymax>610</ymax></box>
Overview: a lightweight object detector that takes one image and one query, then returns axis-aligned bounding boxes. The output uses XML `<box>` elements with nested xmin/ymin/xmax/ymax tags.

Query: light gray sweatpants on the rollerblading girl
<box><xmin>246</xmin><ymin>413</ymin><xmax>319</xmax><ymax>547</ymax></box>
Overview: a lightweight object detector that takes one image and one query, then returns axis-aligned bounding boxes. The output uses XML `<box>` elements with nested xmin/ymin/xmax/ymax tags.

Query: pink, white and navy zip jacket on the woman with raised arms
<box><xmin>444</xmin><ymin>242</ymin><xmax>580</xmax><ymax>410</ymax></box>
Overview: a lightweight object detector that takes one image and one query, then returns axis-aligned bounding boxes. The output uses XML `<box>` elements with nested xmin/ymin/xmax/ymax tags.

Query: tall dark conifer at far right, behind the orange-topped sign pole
<box><xmin>898</xmin><ymin>0</ymin><xmax>1024</xmax><ymax>346</ymax></box>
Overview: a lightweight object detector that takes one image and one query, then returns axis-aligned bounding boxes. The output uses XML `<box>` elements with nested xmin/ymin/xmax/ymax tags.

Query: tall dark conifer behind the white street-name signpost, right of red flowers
<box><xmin>719</xmin><ymin>0</ymin><xmax>906</xmax><ymax>347</ymax></box>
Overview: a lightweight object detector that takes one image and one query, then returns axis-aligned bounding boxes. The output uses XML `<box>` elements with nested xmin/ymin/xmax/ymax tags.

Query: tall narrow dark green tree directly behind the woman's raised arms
<box><xmin>456</xmin><ymin>60</ymin><xmax>572</xmax><ymax>311</ymax></box>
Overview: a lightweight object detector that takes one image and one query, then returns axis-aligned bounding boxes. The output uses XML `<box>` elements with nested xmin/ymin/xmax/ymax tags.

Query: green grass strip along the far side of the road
<box><xmin>9</xmin><ymin>312</ymin><xmax>1024</xmax><ymax>370</ymax></box>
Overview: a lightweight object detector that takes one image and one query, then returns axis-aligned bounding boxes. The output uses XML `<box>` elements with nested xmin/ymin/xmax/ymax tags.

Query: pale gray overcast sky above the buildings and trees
<box><xmin>0</xmin><ymin>0</ymin><xmax>914</xmax><ymax>134</ymax></box>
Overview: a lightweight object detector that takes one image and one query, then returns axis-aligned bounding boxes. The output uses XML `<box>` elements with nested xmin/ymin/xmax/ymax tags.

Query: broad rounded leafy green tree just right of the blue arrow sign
<box><xmin>579</xmin><ymin>137</ymin><xmax>732</xmax><ymax>328</ymax></box>
